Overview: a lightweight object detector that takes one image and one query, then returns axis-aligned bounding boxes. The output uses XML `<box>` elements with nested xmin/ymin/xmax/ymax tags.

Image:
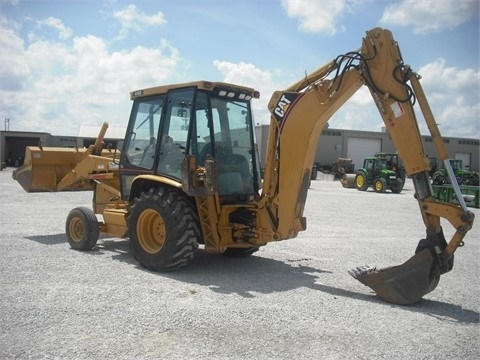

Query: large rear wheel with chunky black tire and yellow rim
<box><xmin>128</xmin><ymin>187</ymin><xmax>201</xmax><ymax>271</ymax></box>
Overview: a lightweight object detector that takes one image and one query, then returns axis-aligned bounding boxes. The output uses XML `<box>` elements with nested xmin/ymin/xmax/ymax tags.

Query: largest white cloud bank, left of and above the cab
<box><xmin>0</xmin><ymin>27</ymin><xmax>188</xmax><ymax>135</ymax></box>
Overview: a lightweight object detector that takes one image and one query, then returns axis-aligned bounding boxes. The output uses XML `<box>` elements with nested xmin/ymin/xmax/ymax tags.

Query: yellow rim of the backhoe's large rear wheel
<box><xmin>137</xmin><ymin>209</ymin><xmax>166</xmax><ymax>254</ymax></box>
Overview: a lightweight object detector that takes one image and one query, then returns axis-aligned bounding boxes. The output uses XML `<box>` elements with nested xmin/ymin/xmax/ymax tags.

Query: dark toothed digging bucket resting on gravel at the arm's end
<box><xmin>349</xmin><ymin>231</ymin><xmax>453</xmax><ymax>305</ymax></box>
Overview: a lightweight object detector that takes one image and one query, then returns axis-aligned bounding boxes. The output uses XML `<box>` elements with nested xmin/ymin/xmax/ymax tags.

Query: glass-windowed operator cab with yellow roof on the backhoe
<box><xmin>120</xmin><ymin>82</ymin><xmax>260</xmax><ymax>203</ymax></box>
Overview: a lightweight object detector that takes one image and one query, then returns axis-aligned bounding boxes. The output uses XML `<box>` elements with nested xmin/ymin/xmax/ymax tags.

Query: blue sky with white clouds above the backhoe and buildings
<box><xmin>0</xmin><ymin>0</ymin><xmax>480</xmax><ymax>139</ymax></box>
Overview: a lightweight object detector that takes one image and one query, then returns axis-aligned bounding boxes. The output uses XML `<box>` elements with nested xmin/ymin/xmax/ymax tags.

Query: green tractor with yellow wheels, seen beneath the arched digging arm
<box><xmin>355</xmin><ymin>156</ymin><xmax>405</xmax><ymax>194</ymax></box>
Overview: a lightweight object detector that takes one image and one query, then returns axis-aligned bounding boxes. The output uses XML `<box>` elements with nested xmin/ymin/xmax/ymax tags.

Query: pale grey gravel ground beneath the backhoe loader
<box><xmin>0</xmin><ymin>168</ymin><xmax>480</xmax><ymax>360</ymax></box>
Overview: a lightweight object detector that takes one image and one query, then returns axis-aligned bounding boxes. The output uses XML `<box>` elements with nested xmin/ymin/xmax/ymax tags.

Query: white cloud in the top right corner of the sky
<box><xmin>380</xmin><ymin>0</ymin><xmax>479</xmax><ymax>34</ymax></box>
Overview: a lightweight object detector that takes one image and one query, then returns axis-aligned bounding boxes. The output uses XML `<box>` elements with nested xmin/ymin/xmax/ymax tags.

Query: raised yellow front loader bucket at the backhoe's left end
<box><xmin>12</xmin><ymin>146</ymin><xmax>93</xmax><ymax>192</ymax></box>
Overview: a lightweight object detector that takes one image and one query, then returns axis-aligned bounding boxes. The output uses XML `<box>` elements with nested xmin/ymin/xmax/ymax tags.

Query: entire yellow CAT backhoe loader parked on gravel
<box><xmin>13</xmin><ymin>28</ymin><xmax>474</xmax><ymax>304</ymax></box>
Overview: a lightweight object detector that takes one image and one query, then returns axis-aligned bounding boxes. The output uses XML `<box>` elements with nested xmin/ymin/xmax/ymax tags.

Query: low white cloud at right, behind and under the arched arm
<box><xmin>330</xmin><ymin>59</ymin><xmax>480</xmax><ymax>138</ymax></box>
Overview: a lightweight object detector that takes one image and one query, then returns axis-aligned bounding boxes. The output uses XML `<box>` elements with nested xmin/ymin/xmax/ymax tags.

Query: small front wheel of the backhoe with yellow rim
<box><xmin>65</xmin><ymin>206</ymin><xmax>100</xmax><ymax>250</ymax></box>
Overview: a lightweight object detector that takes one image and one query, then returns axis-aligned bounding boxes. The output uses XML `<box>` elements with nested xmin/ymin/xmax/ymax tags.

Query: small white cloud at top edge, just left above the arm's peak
<box><xmin>282</xmin><ymin>0</ymin><xmax>347</xmax><ymax>35</ymax></box>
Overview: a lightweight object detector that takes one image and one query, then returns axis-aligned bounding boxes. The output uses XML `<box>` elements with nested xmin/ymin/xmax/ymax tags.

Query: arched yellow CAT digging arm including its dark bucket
<box><xmin>263</xmin><ymin>28</ymin><xmax>474</xmax><ymax>304</ymax></box>
